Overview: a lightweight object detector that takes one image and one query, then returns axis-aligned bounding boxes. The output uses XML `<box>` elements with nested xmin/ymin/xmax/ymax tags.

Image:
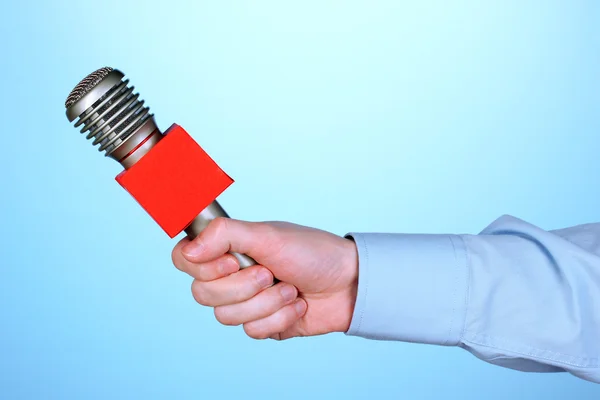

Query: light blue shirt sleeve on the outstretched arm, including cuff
<box><xmin>346</xmin><ymin>216</ymin><xmax>600</xmax><ymax>383</ymax></box>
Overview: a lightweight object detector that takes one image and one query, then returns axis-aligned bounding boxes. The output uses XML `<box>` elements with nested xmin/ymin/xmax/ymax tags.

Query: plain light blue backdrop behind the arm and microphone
<box><xmin>0</xmin><ymin>0</ymin><xmax>600</xmax><ymax>399</ymax></box>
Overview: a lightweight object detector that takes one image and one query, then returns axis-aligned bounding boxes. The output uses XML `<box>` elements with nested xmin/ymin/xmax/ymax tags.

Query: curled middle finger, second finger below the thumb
<box><xmin>192</xmin><ymin>265</ymin><xmax>273</xmax><ymax>307</ymax></box>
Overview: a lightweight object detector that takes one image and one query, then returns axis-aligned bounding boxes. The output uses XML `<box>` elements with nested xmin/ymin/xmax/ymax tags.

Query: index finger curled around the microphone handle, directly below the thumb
<box><xmin>171</xmin><ymin>239</ymin><xmax>240</xmax><ymax>281</ymax></box>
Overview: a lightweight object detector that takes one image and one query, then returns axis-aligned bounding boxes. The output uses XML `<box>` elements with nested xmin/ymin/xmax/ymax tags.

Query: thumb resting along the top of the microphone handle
<box><xmin>182</xmin><ymin>218</ymin><xmax>275</xmax><ymax>262</ymax></box>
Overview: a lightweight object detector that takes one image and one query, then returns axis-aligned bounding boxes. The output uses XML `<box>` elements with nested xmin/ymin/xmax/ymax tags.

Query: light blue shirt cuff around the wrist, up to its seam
<box><xmin>346</xmin><ymin>233</ymin><xmax>468</xmax><ymax>346</ymax></box>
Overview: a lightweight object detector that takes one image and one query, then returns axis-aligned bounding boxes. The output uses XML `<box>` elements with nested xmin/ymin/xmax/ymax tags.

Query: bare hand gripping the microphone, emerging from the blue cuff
<box><xmin>172</xmin><ymin>218</ymin><xmax>358</xmax><ymax>340</ymax></box>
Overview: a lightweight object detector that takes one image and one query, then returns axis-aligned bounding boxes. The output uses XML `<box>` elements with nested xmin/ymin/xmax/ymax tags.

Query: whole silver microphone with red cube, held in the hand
<box><xmin>65</xmin><ymin>67</ymin><xmax>256</xmax><ymax>268</ymax></box>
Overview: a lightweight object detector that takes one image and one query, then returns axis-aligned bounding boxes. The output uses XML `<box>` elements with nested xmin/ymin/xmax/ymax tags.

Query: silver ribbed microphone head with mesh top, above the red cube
<box><xmin>65</xmin><ymin>67</ymin><xmax>160</xmax><ymax>168</ymax></box>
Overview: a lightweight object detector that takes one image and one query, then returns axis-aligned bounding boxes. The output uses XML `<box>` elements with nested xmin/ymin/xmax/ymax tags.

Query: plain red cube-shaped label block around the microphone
<box><xmin>116</xmin><ymin>124</ymin><xmax>233</xmax><ymax>238</ymax></box>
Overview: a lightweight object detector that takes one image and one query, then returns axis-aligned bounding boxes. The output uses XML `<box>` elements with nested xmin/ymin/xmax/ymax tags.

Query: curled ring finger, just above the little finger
<box><xmin>215</xmin><ymin>283</ymin><xmax>298</xmax><ymax>326</ymax></box>
